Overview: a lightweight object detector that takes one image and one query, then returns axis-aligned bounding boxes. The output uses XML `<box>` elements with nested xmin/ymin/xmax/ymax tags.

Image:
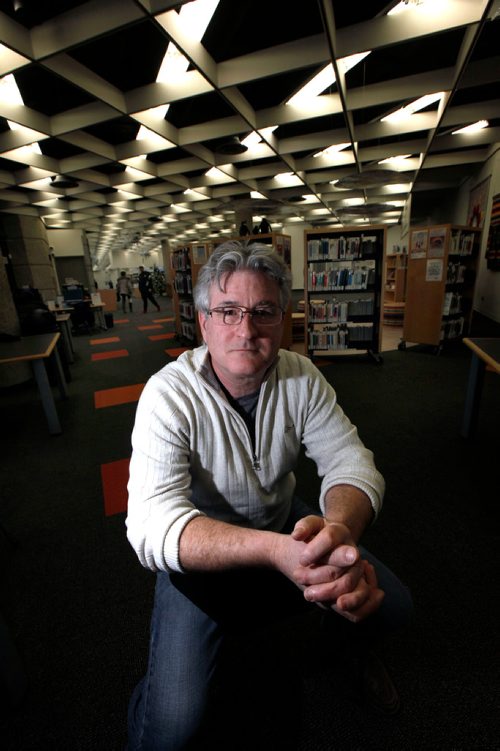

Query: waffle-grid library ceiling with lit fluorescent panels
<box><xmin>0</xmin><ymin>0</ymin><xmax>500</xmax><ymax>269</ymax></box>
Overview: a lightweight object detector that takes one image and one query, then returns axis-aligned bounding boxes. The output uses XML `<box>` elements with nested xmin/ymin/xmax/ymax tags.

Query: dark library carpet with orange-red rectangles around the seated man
<box><xmin>0</xmin><ymin>299</ymin><xmax>500</xmax><ymax>751</ymax></box>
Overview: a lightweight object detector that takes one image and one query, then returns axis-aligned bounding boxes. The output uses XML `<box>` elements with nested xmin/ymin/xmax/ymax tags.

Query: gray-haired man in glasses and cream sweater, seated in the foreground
<box><xmin>127</xmin><ymin>243</ymin><xmax>410</xmax><ymax>751</ymax></box>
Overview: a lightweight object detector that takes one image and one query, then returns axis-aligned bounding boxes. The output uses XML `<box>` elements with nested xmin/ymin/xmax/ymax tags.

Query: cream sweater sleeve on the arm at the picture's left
<box><xmin>126</xmin><ymin>376</ymin><xmax>202</xmax><ymax>572</ymax></box>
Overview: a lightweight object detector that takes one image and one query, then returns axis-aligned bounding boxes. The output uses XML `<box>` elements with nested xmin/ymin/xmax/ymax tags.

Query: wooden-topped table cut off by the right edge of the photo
<box><xmin>460</xmin><ymin>338</ymin><xmax>500</xmax><ymax>438</ymax></box>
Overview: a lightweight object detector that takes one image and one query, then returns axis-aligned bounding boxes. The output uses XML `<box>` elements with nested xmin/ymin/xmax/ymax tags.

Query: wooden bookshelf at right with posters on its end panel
<box><xmin>399</xmin><ymin>224</ymin><xmax>481</xmax><ymax>352</ymax></box>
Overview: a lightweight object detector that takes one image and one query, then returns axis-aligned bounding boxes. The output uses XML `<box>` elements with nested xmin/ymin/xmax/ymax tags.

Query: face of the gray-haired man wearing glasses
<box><xmin>199</xmin><ymin>271</ymin><xmax>283</xmax><ymax>397</ymax></box>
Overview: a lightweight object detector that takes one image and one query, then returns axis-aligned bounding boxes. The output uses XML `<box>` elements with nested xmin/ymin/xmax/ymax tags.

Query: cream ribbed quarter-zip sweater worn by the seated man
<box><xmin>126</xmin><ymin>346</ymin><xmax>384</xmax><ymax>571</ymax></box>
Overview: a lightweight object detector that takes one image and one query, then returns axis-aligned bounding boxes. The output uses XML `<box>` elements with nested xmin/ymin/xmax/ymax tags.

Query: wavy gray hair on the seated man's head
<box><xmin>193</xmin><ymin>240</ymin><xmax>292</xmax><ymax>313</ymax></box>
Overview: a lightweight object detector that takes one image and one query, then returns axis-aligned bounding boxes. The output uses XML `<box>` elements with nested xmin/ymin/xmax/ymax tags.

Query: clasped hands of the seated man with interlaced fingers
<box><xmin>277</xmin><ymin>515</ymin><xmax>384</xmax><ymax>623</ymax></box>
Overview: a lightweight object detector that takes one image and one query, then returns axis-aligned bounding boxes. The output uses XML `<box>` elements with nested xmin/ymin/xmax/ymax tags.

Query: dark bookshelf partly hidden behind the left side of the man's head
<box><xmin>170</xmin><ymin>243</ymin><xmax>212</xmax><ymax>346</ymax></box>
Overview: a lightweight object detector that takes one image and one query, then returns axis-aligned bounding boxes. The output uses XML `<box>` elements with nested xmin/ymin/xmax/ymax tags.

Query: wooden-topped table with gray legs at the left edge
<box><xmin>0</xmin><ymin>331</ymin><xmax>67</xmax><ymax>435</ymax></box>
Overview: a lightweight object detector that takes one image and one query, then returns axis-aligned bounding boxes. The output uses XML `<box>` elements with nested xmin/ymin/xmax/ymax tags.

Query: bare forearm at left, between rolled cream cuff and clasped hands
<box><xmin>179</xmin><ymin>516</ymin><xmax>280</xmax><ymax>571</ymax></box>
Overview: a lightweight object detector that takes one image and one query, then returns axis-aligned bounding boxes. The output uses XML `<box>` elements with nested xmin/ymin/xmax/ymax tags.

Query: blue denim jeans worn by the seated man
<box><xmin>128</xmin><ymin>500</ymin><xmax>412</xmax><ymax>751</ymax></box>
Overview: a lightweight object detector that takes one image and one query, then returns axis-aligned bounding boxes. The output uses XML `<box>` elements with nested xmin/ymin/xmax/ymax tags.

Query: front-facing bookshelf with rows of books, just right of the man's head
<box><xmin>304</xmin><ymin>226</ymin><xmax>386</xmax><ymax>362</ymax></box>
